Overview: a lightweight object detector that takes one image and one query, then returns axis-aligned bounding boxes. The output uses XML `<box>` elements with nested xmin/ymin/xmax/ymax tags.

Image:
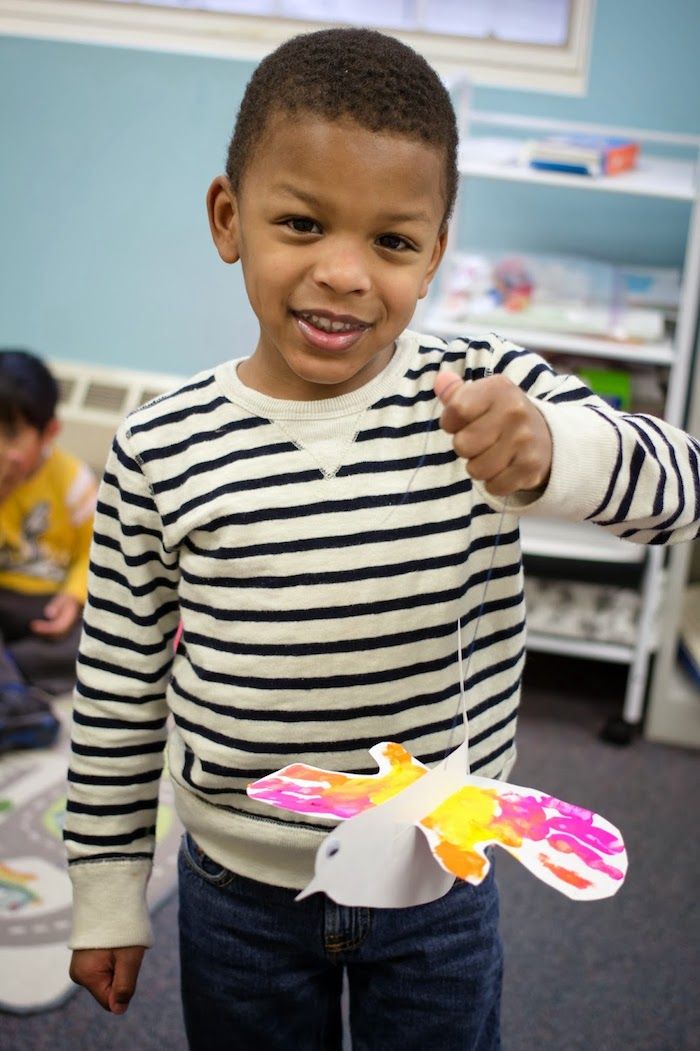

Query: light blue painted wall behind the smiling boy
<box><xmin>0</xmin><ymin>0</ymin><xmax>700</xmax><ymax>374</ymax></box>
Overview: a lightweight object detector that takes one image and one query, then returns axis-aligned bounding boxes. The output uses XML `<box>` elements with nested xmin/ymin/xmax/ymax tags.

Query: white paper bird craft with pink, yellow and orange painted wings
<box><xmin>247</xmin><ymin>742</ymin><xmax>627</xmax><ymax>908</ymax></box>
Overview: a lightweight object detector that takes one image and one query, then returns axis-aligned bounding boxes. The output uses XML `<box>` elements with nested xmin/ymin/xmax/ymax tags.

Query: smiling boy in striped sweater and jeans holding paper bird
<box><xmin>65</xmin><ymin>29</ymin><xmax>698</xmax><ymax>1051</ymax></box>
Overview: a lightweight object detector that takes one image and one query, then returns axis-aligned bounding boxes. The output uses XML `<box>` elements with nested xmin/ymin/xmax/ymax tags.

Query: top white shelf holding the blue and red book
<box><xmin>458</xmin><ymin>136</ymin><xmax>698</xmax><ymax>202</ymax></box>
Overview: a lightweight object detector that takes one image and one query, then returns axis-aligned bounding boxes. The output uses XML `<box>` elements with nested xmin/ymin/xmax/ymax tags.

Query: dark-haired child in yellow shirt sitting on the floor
<box><xmin>0</xmin><ymin>350</ymin><xmax>97</xmax><ymax>749</ymax></box>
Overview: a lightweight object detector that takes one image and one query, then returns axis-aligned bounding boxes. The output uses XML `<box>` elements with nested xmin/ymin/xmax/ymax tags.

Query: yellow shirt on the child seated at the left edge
<box><xmin>0</xmin><ymin>449</ymin><xmax>97</xmax><ymax>603</ymax></box>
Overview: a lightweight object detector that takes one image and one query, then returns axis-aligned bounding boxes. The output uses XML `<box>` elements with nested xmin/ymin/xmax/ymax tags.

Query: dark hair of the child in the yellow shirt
<box><xmin>0</xmin><ymin>350</ymin><xmax>58</xmax><ymax>432</ymax></box>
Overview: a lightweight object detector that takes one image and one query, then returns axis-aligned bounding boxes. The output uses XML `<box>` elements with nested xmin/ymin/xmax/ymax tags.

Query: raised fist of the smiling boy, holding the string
<box><xmin>435</xmin><ymin>372</ymin><xmax>552</xmax><ymax>496</ymax></box>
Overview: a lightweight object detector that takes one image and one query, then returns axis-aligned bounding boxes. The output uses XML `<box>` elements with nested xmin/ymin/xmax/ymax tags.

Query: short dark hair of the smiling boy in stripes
<box><xmin>226</xmin><ymin>28</ymin><xmax>457</xmax><ymax>221</ymax></box>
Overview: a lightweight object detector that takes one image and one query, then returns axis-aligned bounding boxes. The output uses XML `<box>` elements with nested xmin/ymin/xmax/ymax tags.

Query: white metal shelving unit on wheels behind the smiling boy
<box><xmin>420</xmin><ymin>102</ymin><xmax>700</xmax><ymax>740</ymax></box>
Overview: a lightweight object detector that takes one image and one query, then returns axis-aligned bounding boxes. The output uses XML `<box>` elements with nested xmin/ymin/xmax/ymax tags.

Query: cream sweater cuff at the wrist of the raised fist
<box><xmin>474</xmin><ymin>398</ymin><xmax>618</xmax><ymax>522</ymax></box>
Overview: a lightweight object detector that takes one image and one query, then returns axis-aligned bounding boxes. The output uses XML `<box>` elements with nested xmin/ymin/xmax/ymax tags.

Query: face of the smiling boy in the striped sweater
<box><xmin>208</xmin><ymin>114</ymin><xmax>446</xmax><ymax>400</ymax></box>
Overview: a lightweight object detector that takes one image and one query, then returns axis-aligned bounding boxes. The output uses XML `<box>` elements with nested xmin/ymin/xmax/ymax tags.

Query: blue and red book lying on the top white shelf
<box><xmin>522</xmin><ymin>135</ymin><xmax>639</xmax><ymax>177</ymax></box>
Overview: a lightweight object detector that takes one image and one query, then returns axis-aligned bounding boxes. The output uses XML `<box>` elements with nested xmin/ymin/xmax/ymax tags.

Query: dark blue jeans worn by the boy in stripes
<box><xmin>179</xmin><ymin>834</ymin><xmax>502</xmax><ymax>1051</ymax></box>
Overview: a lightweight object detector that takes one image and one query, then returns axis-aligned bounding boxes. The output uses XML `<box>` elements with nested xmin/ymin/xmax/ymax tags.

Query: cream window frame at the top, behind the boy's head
<box><xmin>0</xmin><ymin>0</ymin><xmax>595</xmax><ymax>96</ymax></box>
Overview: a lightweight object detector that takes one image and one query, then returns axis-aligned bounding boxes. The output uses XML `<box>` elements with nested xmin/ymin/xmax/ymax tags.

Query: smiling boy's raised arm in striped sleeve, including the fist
<box><xmin>435</xmin><ymin>335</ymin><xmax>700</xmax><ymax>544</ymax></box>
